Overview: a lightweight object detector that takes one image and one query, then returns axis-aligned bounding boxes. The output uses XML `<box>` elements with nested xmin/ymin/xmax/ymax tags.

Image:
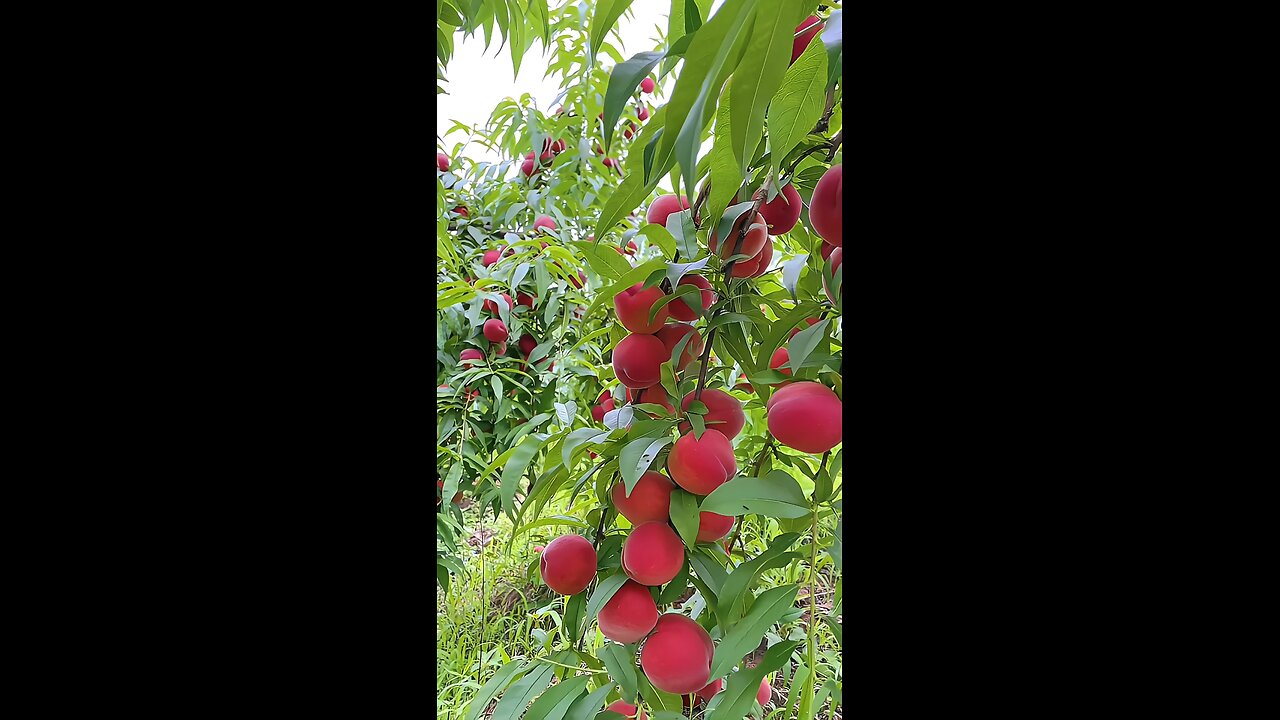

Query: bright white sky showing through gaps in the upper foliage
<box><xmin>435</xmin><ymin>0</ymin><xmax>723</xmax><ymax>163</ymax></box>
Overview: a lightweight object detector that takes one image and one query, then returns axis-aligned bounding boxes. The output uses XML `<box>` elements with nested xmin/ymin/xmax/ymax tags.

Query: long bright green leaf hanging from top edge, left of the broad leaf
<box><xmin>730</xmin><ymin>0</ymin><xmax>809</xmax><ymax>174</ymax></box>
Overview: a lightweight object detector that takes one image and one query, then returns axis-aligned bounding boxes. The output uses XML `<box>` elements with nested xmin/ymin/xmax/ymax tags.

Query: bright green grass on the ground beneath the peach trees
<box><xmin>435</xmin><ymin>489</ymin><xmax>842</xmax><ymax>720</ymax></box>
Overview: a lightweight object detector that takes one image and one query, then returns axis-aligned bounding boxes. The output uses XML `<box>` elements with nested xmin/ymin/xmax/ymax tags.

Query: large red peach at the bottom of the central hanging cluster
<box><xmin>640</xmin><ymin>612</ymin><xmax>716</xmax><ymax>694</ymax></box>
